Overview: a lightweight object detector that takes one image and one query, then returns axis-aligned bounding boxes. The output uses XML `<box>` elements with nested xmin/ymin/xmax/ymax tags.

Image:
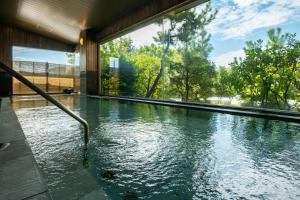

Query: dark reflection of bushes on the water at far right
<box><xmin>232</xmin><ymin>117</ymin><xmax>300</xmax><ymax>170</ymax></box>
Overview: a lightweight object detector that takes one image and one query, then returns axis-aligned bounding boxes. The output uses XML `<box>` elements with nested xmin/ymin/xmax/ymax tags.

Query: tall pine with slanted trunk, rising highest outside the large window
<box><xmin>146</xmin><ymin>2</ymin><xmax>217</xmax><ymax>99</ymax></box>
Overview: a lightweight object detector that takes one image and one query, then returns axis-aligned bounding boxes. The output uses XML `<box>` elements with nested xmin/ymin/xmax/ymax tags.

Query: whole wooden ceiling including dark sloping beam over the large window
<box><xmin>0</xmin><ymin>0</ymin><xmax>207</xmax><ymax>44</ymax></box>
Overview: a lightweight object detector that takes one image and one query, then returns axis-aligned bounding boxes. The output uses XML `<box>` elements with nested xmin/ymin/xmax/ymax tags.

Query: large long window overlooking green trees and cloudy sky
<box><xmin>100</xmin><ymin>0</ymin><xmax>300</xmax><ymax>110</ymax></box>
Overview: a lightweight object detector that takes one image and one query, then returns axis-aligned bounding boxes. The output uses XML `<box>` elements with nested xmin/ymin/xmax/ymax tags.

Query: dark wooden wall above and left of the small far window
<box><xmin>0</xmin><ymin>24</ymin><xmax>75</xmax><ymax>96</ymax></box>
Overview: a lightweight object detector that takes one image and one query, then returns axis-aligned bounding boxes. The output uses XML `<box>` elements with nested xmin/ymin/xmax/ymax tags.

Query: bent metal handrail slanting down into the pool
<box><xmin>0</xmin><ymin>62</ymin><xmax>89</xmax><ymax>150</ymax></box>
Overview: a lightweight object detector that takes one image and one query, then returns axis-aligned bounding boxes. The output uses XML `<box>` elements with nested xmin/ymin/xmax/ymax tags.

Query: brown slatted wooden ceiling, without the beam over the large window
<box><xmin>0</xmin><ymin>0</ymin><xmax>151</xmax><ymax>44</ymax></box>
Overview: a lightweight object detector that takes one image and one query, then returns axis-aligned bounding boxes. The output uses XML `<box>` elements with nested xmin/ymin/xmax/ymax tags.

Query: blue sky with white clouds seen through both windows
<box><xmin>13</xmin><ymin>0</ymin><xmax>300</xmax><ymax>66</ymax></box>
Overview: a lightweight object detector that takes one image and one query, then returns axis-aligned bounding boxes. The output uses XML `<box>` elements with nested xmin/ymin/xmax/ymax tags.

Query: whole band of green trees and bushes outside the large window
<box><xmin>100</xmin><ymin>3</ymin><xmax>300</xmax><ymax>109</ymax></box>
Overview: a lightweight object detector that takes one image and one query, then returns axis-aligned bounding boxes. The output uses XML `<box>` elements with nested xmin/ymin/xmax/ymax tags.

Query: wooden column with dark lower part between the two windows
<box><xmin>80</xmin><ymin>31</ymin><xmax>99</xmax><ymax>95</ymax></box>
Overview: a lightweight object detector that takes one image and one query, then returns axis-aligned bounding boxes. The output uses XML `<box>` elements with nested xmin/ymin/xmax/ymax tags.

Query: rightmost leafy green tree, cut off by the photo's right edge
<box><xmin>267</xmin><ymin>28</ymin><xmax>300</xmax><ymax>109</ymax></box>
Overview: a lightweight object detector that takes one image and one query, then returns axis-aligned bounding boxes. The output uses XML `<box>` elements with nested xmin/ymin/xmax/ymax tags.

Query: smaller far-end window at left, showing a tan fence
<box><xmin>13</xmin><ymin>47</ymin><xmax>80</xmax><ymax>94</ymax></box>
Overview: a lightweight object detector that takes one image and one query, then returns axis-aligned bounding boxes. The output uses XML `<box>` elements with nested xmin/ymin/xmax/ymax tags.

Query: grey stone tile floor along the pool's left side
<box><xmin>0</xmin><ymin>98</ymin><xmax>51</xmax><ymax>200</ymax></box>
